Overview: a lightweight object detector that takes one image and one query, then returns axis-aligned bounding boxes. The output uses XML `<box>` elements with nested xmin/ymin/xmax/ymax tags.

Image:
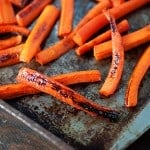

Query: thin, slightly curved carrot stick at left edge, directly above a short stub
<box><xmin>0</xmin><ymin>25</ymin><xmax>30</xmax><ymax>36</ymax></box>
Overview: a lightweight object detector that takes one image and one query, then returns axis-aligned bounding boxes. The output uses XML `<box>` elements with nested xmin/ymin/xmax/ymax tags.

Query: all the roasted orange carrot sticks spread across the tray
<box><xmin>0</xmin><ymin>0</ymin><xmax>150</xmax><ymax>121</ymax></box>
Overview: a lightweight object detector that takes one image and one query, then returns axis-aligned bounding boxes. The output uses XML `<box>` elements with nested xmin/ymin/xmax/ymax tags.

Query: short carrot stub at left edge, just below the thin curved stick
<box><xmin>0</xmin><ymin>35</ymin><xmax>22</xmax><ymax>50</ymax></box>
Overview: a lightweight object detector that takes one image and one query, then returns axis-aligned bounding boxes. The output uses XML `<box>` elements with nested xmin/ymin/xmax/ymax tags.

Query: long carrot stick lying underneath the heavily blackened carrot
<box><xmin>0</xmin><ymin>70</ymin><xmax>101</xmax><ymax>99</ymax></box>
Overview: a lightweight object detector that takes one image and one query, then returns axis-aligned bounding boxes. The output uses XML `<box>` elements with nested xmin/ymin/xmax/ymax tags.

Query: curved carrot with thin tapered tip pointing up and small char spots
<box><xmin>99</xmin><ymin>11</ymin><xmax>124</xmax><ymax>96</ymax></box>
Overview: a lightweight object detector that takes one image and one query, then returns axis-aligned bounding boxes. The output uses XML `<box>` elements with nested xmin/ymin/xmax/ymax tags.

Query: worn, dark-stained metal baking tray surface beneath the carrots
<box><xmin>0</xmin><ymin>0</ymin><xmax>150</xmax><ymax>149</ymax></box>
